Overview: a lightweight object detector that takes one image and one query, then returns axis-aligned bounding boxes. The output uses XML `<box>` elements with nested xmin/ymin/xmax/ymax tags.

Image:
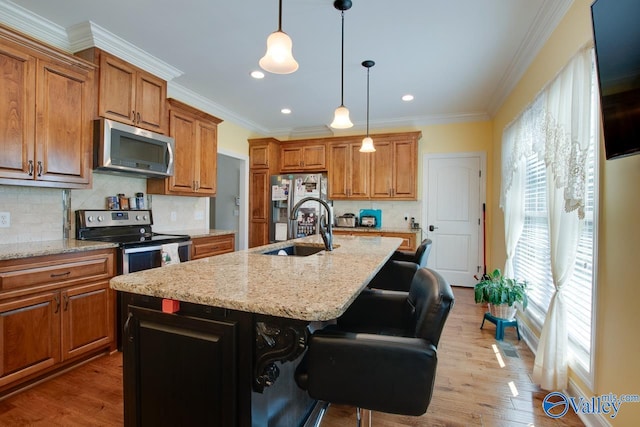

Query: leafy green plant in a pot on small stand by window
<box><xmin>475</xmin><ymin>269</ymin><xmax>528</xmax><ymax>319</ymax></box>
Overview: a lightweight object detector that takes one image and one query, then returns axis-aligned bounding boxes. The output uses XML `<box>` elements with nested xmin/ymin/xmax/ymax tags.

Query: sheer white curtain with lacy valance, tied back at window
<box><xmin>501</xmin><ymin>48</ymin><xmax>592</xmax><ymax>390</ymax></box>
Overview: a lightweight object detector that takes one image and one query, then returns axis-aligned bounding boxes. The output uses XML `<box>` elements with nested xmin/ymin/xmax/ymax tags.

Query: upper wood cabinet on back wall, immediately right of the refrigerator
<box><xmin>329</xmin><ymin>140</ymin><xmax>370</xmax><ymax>200</ymax></box>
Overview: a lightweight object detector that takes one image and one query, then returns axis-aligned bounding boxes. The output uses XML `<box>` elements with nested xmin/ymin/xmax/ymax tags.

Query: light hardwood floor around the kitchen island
<box><xmin>0</xmin><ymin>288</ymin><xmax>583</xmax><ymax>427</ymax></box>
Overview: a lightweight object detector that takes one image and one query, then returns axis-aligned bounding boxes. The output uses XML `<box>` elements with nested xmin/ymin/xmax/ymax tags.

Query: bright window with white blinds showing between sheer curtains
<box><xmin>513</xmin><ymin>61</ymin><xmax>599</xmax><ymax>373</ymax></box>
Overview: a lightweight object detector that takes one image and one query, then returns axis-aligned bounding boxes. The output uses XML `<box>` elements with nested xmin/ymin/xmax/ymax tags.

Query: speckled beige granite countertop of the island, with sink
<box><xmin>110</xmin><ymin>235</ymin><xmax>402</xmax><ymax>321</ymax></box>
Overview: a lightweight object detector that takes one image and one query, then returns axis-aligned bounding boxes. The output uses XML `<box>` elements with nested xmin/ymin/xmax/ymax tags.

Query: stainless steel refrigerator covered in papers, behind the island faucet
<box><xmin>269</xmin><ymin>173</ymin><xmax>333</xmax><ymax>243</ymax></box>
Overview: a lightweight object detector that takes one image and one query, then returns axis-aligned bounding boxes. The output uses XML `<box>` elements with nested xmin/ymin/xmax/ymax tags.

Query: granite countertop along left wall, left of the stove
<box><xmin>0</xmin><ymin>239</ymin><xmax>118</xmax><ymax>260</ymax></box>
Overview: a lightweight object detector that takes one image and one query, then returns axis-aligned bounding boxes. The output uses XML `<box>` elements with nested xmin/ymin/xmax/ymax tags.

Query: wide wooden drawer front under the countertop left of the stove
<box><xmin>0</xmin><ymin>252</ymin><xmax>114</xmax><ymax>292</ymax></box>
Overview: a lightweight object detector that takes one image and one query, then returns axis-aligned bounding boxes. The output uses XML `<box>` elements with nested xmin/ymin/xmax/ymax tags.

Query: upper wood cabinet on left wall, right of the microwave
<box><xmin>147</xmin><ymin>99</ymin><xmax>222</xmax><ymax>197</ymax></box>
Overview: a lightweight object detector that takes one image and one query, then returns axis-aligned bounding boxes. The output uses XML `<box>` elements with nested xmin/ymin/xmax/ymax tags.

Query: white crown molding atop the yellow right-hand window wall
<box><xmin>487</xmin><ymin>0</ymin><xmax>573</xmax><ymax>116</ymax></box>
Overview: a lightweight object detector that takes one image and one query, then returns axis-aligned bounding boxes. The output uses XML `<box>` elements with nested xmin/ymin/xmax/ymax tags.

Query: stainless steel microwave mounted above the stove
<box><xmin>94</xmin><ymin>119</ymin><xmax>175</xmax><ymax>178</ymax></box>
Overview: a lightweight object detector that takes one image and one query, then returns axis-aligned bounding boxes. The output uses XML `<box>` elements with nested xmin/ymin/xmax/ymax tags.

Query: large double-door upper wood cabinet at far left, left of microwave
<box><xmin>0</xmin><ymin>26</ymin><xmax>94</xmax><ymax>188</ymax></box>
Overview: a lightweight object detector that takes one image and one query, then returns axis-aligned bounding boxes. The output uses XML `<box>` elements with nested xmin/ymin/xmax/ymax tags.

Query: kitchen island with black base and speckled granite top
<box><xmin>111</xmin><ymin>236</ymin><xmax>401</xmax><ymax>426</ymax></box>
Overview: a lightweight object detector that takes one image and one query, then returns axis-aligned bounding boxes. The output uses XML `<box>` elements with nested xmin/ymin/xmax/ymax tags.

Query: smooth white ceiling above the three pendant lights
<box><xmin>0</xmin><ymin>0</ymin><xmax>572</xmax><ymax>136</ymax></box>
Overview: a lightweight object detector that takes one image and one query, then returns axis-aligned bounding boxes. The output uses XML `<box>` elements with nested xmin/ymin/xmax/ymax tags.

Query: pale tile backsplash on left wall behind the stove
<box><xmin>0</xmin><ymin>173</ymin><xmax>209</xmax><ymax>244</ymax></box>
